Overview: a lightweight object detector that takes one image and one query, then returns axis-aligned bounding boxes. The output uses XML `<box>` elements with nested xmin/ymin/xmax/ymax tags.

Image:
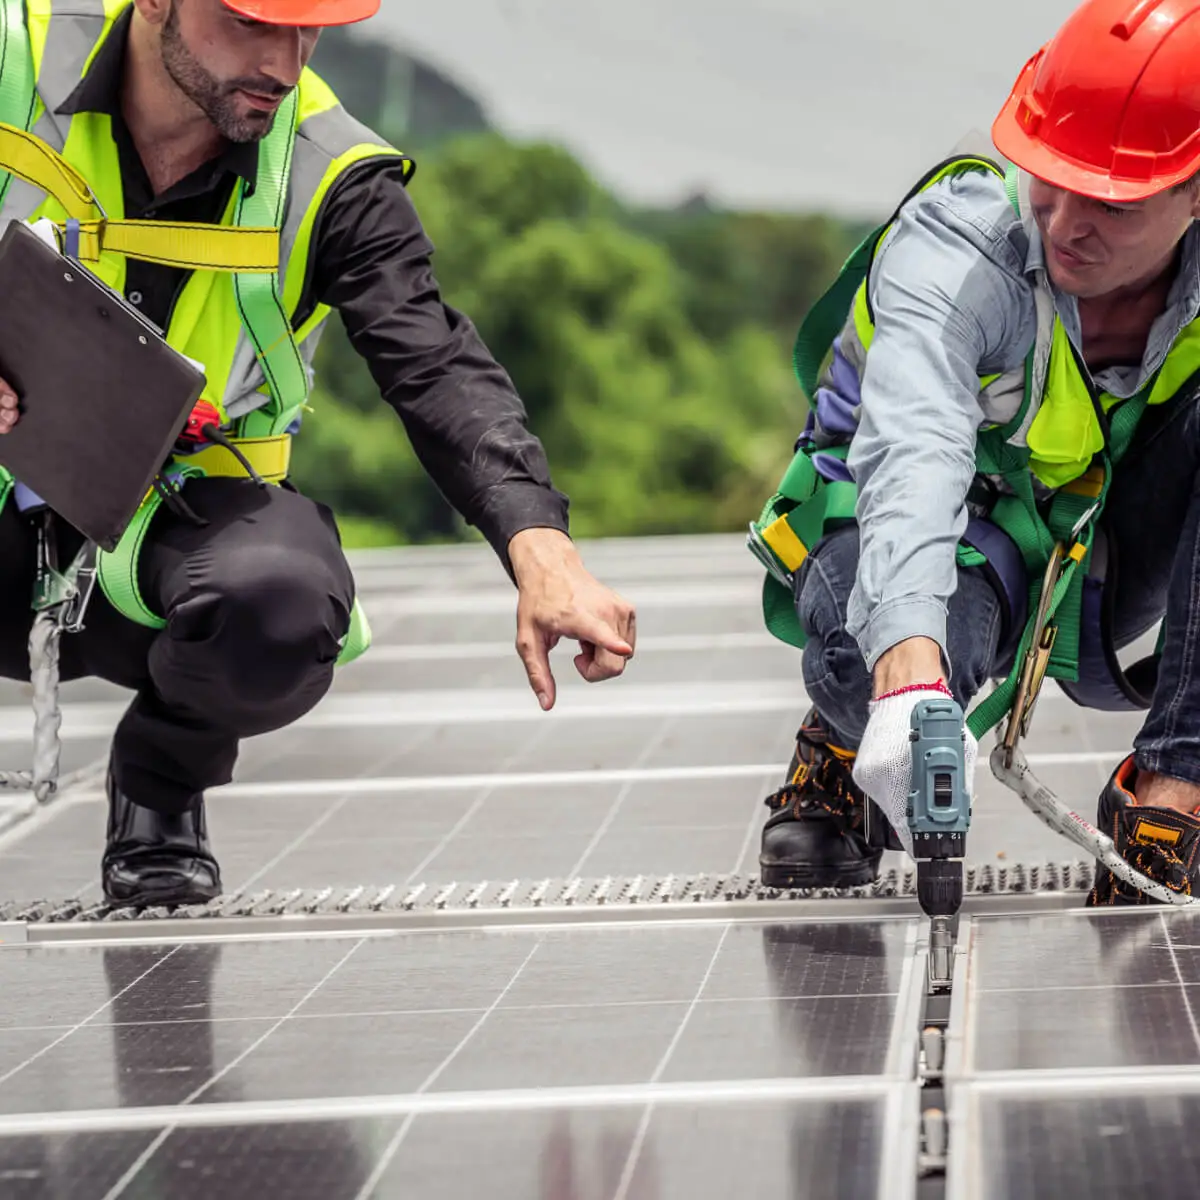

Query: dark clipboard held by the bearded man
<box><xmin>0</xmin><ymin>221</ymin><xmax>205</xmax><ymax>551</ymax></box>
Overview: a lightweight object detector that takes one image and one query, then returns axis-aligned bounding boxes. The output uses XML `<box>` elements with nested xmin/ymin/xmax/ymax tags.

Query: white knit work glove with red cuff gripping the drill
<box><xmin>854</xmin><ymin>688</ymin><xmax>979</xmax><ymax>857</ymax></box>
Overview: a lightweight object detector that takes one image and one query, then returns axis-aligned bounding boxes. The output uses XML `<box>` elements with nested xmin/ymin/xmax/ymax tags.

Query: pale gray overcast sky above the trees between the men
<box><xmin>373</xmin><ymin>0</ymin><xmax>1089</xmax><ymax>215</ymax></box>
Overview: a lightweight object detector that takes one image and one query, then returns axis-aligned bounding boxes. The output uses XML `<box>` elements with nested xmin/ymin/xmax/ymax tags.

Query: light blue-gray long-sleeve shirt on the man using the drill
<box><xmin>847</xmin><ymin>172</ymin><xmax>1200</xmax><ymax>670</ymax></box>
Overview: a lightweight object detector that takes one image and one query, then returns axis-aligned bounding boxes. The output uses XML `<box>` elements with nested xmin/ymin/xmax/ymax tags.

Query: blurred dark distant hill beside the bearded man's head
<box><xmin>312</xmin><ymin>26</ymin><xmax>492</xmax><ymax>150</ymax></box>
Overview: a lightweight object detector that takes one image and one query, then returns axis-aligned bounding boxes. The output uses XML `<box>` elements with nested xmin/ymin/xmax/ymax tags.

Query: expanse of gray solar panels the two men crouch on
<box><xmin>0</xmin><ymin>538</ymin><xmax>1200</xmax><ymax>1200</ymax></box>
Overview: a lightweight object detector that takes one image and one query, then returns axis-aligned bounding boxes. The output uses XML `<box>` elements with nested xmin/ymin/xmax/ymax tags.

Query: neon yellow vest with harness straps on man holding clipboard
<box><xmin>0</xmin><ymin>0</ymin><xmax>414</xmax><ymax>661</ymax></box>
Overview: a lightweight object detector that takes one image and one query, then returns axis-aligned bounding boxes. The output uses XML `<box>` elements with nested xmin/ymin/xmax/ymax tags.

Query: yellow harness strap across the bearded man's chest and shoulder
<box><xmin>0</xmin><ymin>124</ymin><xmax>280</xmax><ymax>274</ymax></box>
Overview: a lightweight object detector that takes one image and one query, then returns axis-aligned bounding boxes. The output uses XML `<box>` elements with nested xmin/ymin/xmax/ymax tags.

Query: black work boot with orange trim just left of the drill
<box><xmin>758</xmin><ymin>708</ymin><xmax>904</xmax><ymax>888</ymax></box>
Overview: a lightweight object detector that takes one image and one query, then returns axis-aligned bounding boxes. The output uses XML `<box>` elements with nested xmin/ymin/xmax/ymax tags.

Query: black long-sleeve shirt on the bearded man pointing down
<box><xmin>56</xmin><ymin>8</ymin><xmax>568</xmax><ymax>569</ymax></box>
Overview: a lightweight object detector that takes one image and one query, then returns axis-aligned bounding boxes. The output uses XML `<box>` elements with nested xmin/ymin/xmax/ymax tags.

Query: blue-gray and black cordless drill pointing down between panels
<box><xmin>906</xmin><ymin>697</ymin><xmax>971</xmax><ymax>984</ymax></box>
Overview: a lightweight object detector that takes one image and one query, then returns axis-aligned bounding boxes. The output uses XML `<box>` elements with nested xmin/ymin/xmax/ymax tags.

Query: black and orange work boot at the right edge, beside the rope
<box><xmin>1087</xmin><ymin>755</ymin><xmax>1200</xmax><ymax>908</ymax></box>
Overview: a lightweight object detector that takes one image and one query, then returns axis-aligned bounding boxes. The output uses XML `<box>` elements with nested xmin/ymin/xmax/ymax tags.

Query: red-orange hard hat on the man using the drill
<box><xmin>991</xmin><ymin>0</ymin><xmax>1200</xmax><ymax>203</ymax></box>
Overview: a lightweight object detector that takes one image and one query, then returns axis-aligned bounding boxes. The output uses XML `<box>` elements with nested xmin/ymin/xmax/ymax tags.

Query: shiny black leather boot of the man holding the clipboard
<box><xmin>101</xmin><ymin>767</ymin><xmax>221</xmax><ymax>908</ymax></box>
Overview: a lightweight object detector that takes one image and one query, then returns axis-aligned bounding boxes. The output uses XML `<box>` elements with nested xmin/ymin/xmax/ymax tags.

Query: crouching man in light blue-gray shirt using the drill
<box><xmin>761</xmin><ymin>0</ymin><xmax>1200</xmax><ymax>904</ymax></box>
